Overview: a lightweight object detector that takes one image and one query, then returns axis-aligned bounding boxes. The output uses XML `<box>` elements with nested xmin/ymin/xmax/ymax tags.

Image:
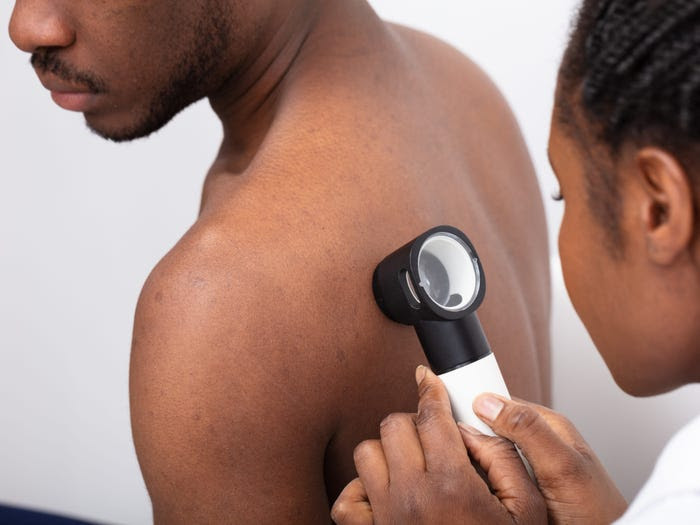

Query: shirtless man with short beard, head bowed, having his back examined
<box><xmin>10</xmin><ymin>0</ymin><xmax>549</xmax><ymax>524</ymax></box>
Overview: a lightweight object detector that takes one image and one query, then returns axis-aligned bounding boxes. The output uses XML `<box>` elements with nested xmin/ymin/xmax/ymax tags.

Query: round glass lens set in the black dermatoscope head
<box><xmin>418</xmin><ymin>233</ymin><xmax>480</xmax><ymax>312</ymax></box>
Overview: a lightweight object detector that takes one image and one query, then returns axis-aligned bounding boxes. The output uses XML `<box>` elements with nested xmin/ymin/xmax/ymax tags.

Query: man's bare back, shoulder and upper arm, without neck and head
<box><xmin>132</xmin><ymin>3</ymin><xmax>549</xmax><ymax>523</ymax></box>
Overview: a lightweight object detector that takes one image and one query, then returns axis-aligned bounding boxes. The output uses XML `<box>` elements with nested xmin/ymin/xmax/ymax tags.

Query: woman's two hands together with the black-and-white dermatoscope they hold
<box><xmin>332</xmin><ymin>226</ymin><xmax>626</xmax><ymax>525</ymax></box>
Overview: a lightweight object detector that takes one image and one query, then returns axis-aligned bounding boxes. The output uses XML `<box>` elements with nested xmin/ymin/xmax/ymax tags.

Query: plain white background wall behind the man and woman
<box><xmin>0</xmin><ymin>0</ymin><xmax>699</xmax><ymax>524</ymax></box>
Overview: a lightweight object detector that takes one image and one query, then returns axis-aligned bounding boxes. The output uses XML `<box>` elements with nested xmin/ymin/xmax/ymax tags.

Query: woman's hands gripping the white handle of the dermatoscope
<box><xmin>332</xmin><ymin>368</ymin><xmax>627</xmax><ymax>525</ymax></box>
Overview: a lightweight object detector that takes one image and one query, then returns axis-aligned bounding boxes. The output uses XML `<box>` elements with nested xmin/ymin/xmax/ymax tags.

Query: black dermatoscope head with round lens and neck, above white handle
<box><xmin>372</xmin><ymin>226</ymin><xmax>491</xmax><ymax>375</ymax></box>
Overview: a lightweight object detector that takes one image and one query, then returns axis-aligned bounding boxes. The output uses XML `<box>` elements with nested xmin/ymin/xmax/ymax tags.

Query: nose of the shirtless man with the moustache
<box><xmin>10</xmin><ymin>0</ymin><xmax>75</xmax><ymax>53</ymax></box>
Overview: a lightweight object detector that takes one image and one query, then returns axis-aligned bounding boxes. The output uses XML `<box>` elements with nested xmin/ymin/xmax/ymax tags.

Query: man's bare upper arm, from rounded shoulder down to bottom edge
<box><xmin>130</xmin><ymin>230</ymin><xmax>340</xmax><ymax>523</ymax></box>
